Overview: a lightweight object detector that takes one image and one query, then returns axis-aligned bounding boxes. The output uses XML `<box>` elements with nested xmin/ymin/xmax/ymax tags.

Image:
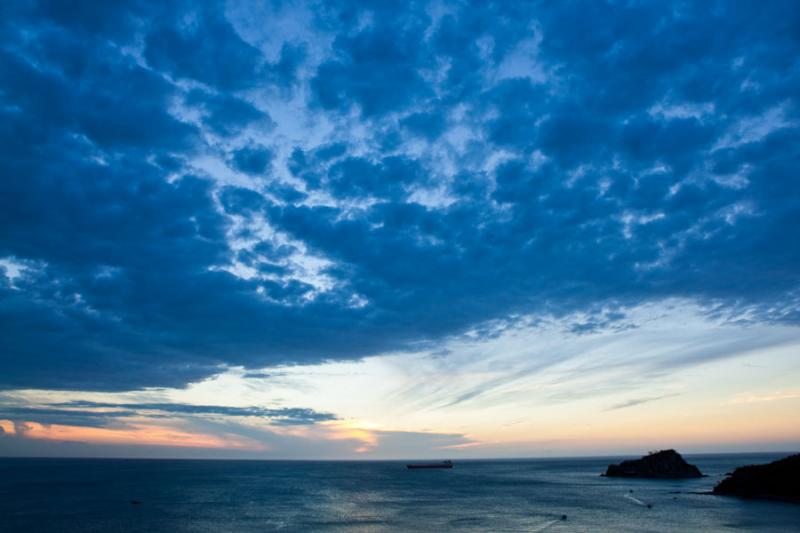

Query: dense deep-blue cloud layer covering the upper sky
<box><xmin>0</xmin><ymin>0</ymin><xmax>800</xmax><ymax>390</ymax></box>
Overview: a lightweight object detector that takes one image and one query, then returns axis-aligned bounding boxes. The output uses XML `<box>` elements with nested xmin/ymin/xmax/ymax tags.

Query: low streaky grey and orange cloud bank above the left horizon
<box><xmin>0</xmin><ymin>397</ymin><xmax>477</xmax><ymax>459</ymax></box>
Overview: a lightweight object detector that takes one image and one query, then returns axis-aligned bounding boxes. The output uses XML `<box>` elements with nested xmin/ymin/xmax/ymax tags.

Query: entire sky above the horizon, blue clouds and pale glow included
<box><xmin>0</xmin><ymin>0</ymin><xmax>800</xmax><ymax>459</ymax></box>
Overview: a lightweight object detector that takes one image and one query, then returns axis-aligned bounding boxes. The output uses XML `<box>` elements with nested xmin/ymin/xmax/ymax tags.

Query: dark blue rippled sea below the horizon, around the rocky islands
<box><xmin>0</xmin><ymin>454</ymin><xmax>800</xmax><ymax>533</ymax></box>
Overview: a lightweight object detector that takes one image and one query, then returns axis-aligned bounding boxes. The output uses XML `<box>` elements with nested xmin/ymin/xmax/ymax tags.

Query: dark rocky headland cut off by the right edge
<box><xmin>714</xmin><ymin>454</ymin><xmax>800</xmax><ymax>503</ymax></box>
